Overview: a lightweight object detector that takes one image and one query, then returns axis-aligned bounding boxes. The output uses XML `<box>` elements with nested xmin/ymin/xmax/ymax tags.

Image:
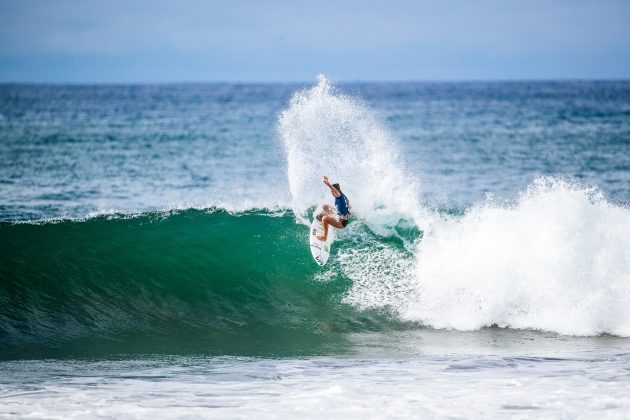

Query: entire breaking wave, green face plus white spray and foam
<box><xmin>0</xmin><ymin>78</ymin><xmax>630</xmax><ymax>357</ymax></box>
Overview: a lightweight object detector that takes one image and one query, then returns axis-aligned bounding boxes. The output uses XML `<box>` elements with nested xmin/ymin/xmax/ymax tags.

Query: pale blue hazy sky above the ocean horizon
<box><xmin>0</xmin><ymin>0</ymin><xmax>630</xmax><ymax>83</ymax></box>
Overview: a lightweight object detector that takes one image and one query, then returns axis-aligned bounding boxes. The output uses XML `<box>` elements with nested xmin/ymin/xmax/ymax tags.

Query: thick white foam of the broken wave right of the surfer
<box><xmin>408</xmin><ymin>178</ymin><xmax>630</xmax><ymax>336</ymax></box>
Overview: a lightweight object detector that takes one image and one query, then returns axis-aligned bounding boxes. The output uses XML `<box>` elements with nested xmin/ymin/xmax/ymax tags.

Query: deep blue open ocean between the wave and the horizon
<box><xmin>0</xmin><ymin>81</ymin><xmax>630</xmax><ymax>220</ymax></box>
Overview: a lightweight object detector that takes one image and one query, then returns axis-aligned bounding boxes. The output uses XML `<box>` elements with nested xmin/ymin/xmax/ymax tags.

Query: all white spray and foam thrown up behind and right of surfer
<box><xmin>279</xmin><ymin>76</ymin><xmax>630</xmax><ymax>336</ymax></box>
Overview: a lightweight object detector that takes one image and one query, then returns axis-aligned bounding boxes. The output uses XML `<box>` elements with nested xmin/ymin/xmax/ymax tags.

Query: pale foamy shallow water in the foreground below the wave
<box><xmin>0</xmin><ymin>336</ymin><xmax>630</xmax><ymax>419</ymax></box>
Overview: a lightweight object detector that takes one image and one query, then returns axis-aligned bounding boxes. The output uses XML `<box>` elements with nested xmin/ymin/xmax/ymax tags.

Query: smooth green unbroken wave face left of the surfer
<box><xmin>0</xmin><ymin>210</ymin><xmax>414</xmax><ymax>358</ymax></box>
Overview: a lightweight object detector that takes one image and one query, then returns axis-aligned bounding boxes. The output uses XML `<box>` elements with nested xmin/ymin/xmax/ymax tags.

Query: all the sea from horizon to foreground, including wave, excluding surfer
<box><xmin>0</xmin><ymin>76</ymin><xmax>630</xmax><ymax>418</ymax></box>
